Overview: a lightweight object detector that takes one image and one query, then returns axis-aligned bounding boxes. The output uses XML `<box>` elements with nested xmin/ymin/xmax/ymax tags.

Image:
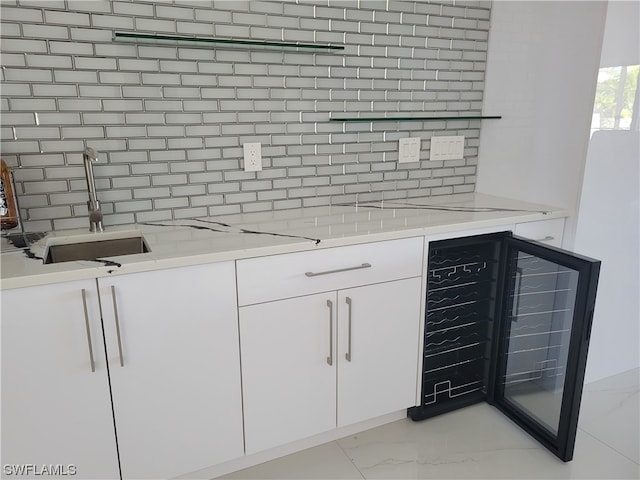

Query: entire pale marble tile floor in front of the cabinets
<box><xmin>222</xmin><ymin>369</ymin><xmax>640</xmax><ymax>480</ymax></box>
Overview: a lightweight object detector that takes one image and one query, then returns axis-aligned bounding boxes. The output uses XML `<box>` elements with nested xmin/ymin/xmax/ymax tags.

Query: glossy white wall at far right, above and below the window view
<box><xmin>574</xmin><ymin>1</ymin><xmax>640</xmax><ymax>381</ymax></box>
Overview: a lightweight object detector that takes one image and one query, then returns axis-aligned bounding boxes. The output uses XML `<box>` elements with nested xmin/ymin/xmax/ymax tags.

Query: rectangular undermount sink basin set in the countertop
<box><xmin>44</xmin><ymin>234</ymin><xmax>151</xmax><ymax>264</ymax></box>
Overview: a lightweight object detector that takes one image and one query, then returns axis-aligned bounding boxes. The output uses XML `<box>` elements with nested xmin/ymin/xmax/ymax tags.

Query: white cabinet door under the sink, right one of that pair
<box><xmin>99</xmin><ymin>262</ymin><xmax>243</xmax><ymax>478</ymax></box>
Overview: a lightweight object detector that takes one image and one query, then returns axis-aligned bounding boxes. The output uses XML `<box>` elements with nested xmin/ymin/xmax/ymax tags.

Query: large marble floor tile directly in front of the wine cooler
<box><xmin>338</xmin><ymin>404</ymin><xmax>639</xmax><ymax>479</ymax></box>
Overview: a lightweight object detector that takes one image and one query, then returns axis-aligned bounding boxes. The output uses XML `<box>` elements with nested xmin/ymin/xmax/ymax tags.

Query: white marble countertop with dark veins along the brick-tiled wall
<box><xmin>0</xmin><ymin>193</ymin><xmax>569</xmax><ymax>289</ymax></box>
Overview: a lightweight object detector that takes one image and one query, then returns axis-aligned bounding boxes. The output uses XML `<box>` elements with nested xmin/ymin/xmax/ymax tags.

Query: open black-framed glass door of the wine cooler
<box><xmin>492</xmin><ymin>237</ymin><xmax>600</xmax><ymax>461</ymax></box>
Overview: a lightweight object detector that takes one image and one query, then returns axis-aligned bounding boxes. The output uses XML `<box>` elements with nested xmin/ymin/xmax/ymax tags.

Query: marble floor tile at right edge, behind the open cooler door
<box><xmin>579</xmin><ymin>369</ymin><xmax>640</xmax><ymax>463</ymax></box>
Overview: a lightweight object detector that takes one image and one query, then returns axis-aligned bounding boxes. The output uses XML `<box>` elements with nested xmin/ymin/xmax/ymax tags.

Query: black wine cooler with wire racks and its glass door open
<box><xmin>408</xmin><ymin>232</ymin><xmax>600</xmax><ymax>461</ymax></box>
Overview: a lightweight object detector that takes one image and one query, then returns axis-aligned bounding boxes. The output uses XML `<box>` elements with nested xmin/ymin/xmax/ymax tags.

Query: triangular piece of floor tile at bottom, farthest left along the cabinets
<box><xmin>221</xmin><ymin>442</ymin><xmax>364</xmax><ymax>480</ymax></box>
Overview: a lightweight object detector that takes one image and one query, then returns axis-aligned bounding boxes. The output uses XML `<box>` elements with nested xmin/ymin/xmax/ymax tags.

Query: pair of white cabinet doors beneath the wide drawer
<box><xmin>239</xmin><ymin>277</ymin><xmax>421</xmax><ymax>454</ymax></box>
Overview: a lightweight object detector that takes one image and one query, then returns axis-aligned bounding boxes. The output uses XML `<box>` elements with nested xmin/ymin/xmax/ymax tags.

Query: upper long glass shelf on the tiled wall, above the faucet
<box><xmin>113</xmin><ymin>32</ymin><xmax>344</xmax><ymax>51</ymax></box>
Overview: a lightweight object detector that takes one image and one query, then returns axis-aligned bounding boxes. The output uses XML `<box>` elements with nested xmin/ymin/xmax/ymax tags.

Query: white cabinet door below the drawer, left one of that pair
<box><xmin>240</xmin><ymin>293</ymin><xmax>336</xmax><ymax>454</ymax></box>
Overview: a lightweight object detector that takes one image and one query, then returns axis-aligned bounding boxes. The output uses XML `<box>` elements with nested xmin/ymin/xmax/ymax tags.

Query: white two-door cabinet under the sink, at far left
<box><xmin>2</xmin><ymin>262</ymin><xmax>244</xmax><ymax>479</ymax></box>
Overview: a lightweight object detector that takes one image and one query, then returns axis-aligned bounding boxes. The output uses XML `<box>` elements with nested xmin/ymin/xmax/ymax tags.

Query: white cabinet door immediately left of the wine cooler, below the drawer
<box><xmin>338</xmin><ymin>278</ymin><xmax>421</xmax><ymax>427</ymax></box>
